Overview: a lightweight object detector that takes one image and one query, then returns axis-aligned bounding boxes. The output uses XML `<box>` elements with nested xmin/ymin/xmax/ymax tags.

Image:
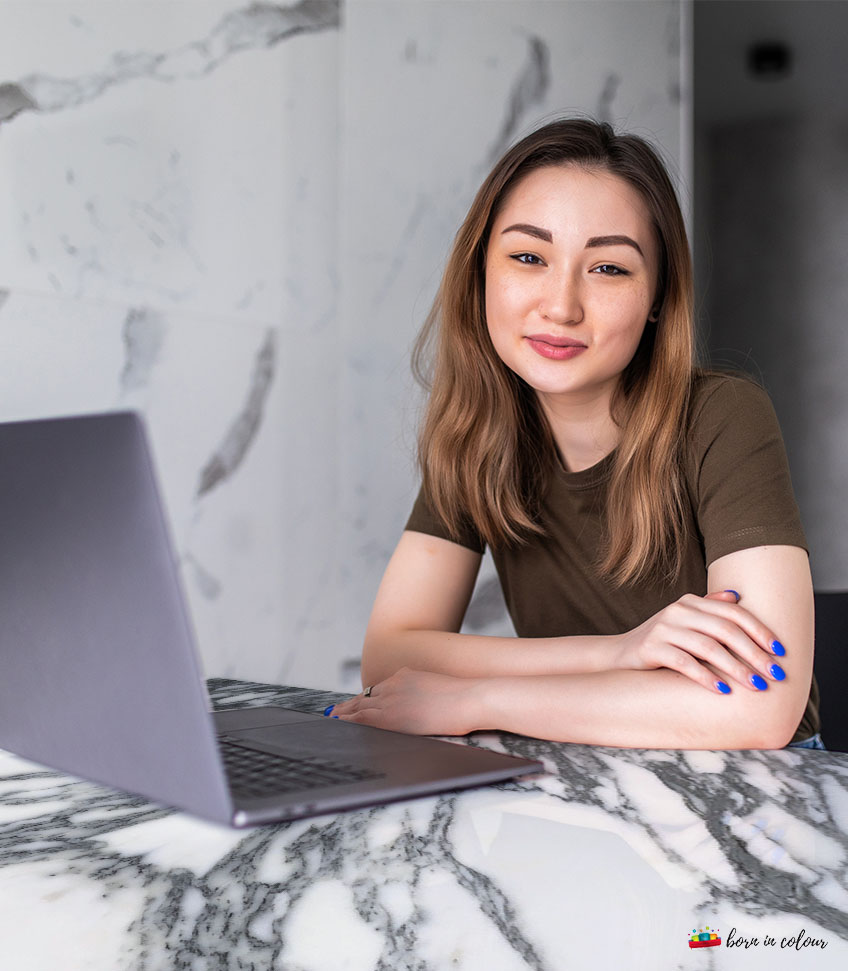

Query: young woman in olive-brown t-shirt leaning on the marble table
<box><xmin>332</xmin><ymin>120</ymin><xmax>819</xmax><ymax>748</ymax></box>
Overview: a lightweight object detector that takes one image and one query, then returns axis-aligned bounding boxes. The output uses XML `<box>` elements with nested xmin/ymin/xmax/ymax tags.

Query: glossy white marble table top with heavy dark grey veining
<box><xmin>0</xmin><ymin>680</ymin><xmax>848</xmax><ymax>971</ymax></box>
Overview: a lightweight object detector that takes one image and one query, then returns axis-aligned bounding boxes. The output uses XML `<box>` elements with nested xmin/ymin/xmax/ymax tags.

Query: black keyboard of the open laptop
<box><xmin>218</xmin><ymin>738</ymin><xmax>383</xmax><ymax>796</ymax></box>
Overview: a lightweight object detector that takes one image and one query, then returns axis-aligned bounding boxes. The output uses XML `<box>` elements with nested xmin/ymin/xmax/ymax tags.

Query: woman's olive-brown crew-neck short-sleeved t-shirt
<box><xmin>406</xmin><ymin>375</ymin><xmax>819</xmax><ymax>739</ymax></box>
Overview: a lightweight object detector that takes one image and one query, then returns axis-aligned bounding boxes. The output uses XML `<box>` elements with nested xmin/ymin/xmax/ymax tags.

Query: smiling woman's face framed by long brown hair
<box><xmin>486</xmin><ymin>165</ymin><xmax>658</xmax><ymax>407</ymax></box>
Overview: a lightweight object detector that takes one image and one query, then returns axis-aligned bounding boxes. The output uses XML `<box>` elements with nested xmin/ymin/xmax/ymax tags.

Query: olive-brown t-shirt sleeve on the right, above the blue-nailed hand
<box><xmin>687</xmin><ymin>376</ymin><xmax>807</xmax><ymax>566</ymax></box>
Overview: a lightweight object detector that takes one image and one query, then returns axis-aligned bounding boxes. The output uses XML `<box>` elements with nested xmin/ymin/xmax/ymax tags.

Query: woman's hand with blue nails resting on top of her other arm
<box><xmin>618</xmin><ymin>590</ymin><xmax>786</xmax><ymax>694</ymax></box>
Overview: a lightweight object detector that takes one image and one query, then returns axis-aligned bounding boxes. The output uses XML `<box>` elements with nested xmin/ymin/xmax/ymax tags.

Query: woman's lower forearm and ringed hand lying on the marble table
<box><xmin>333</xmin><ymin>657</ymin><xmax>810</xmax><ymax>749</ymax></box>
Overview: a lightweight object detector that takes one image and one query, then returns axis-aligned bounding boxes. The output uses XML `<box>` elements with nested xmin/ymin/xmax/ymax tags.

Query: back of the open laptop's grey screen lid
<box><xmin>0</xmin><ymin>412</ymin><xmax>232</xmax><ymax>822</ymax></box>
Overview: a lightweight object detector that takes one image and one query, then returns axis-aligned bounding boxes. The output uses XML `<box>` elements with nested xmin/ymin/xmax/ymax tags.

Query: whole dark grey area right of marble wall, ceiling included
<box><xmin>695</xmin><ymin>0</ymin><xmax>848</xmax><ymax>589</ymax></box>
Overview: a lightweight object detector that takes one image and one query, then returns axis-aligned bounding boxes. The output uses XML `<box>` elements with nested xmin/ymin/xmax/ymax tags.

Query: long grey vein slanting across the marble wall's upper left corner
<box><xmin>0</xmin><ymin>0</ymin><xmax>340</xmax><ymax>125</ymax></box>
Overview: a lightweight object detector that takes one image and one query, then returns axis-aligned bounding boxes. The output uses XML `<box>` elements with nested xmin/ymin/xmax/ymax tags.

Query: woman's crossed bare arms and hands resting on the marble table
<box><xmin>333</xmin><ymin>532</ymin><xmax>813</xmax><ymax>749</ymax></box>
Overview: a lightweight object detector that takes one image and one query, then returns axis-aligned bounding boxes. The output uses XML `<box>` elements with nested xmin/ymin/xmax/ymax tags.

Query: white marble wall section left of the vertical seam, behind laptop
<box><xmin>0</xmin><ymin>0</ymin><xmax>340</xmax><ymax>681</ymax></box>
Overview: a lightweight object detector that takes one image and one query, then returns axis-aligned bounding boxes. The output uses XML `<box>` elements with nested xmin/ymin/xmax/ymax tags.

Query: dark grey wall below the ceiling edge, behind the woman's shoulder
<box><xmin>707</xmin><ymin>114</ymin><xmax>848</xmax><ymax>589</ymax></box>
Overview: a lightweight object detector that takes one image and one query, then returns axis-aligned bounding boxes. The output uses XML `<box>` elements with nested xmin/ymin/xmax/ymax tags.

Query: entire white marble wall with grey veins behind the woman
<box><xmin>0</xmin><ymin>0</ymin><xmax>688</xmax><ymax>688</ymax></box>
